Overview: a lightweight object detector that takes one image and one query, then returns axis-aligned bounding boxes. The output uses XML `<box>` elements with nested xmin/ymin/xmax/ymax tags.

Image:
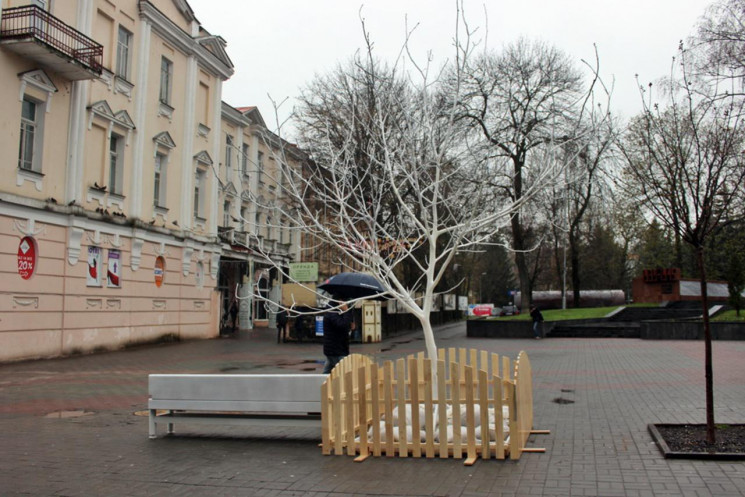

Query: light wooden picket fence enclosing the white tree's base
<box><xmin>321</xmin><ymin>348</ymin><xmax>533</xmax><ymax>464</ymax></box>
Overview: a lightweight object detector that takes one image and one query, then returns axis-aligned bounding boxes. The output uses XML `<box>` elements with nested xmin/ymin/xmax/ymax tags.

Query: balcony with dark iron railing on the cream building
<box><xmin>0</xmin><ymin>5</ymin><xmax>103</xmax><ymax>81</ymax></box>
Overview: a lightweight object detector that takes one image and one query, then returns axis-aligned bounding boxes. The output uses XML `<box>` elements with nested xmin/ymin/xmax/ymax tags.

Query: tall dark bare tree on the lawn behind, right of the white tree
<box><xmin>451</xmin><ymin>39</ymin><xmax>596</xmax><ymax>307</ymax></box>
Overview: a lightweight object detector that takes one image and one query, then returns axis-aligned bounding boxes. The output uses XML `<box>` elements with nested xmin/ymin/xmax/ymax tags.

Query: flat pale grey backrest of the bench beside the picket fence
<box><xmin>148</xmin><ymin>374</ymin><xmax>327</xmax><ymax>414</ymax></box>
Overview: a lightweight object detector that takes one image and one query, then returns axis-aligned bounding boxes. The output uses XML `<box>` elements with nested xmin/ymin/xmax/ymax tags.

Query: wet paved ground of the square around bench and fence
<box><xmin>0</xmin><ymin>323</ymin><xmax>745</xmax><ymax>497</ymax></box>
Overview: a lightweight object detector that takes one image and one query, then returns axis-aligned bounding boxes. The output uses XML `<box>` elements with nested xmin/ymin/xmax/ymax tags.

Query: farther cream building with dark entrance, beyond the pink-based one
<box><xmin>218</xmin><ymin>103</ymin><xmax>307</xmax><ymax>327</ymax></box>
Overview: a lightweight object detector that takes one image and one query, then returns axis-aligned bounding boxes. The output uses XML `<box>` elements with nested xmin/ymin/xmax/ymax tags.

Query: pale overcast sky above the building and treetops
<box><xmin>183</xmin><ymin>0</ymin><xmax>711</xmax><ymax>133</ymax></box>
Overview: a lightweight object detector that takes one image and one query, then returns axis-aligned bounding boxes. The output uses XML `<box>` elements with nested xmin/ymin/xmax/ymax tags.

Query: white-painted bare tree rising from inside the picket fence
<box><xmin>247</xmin><ymin>9</ymin><xmax>608</xmax><ymax>358</ymax></box>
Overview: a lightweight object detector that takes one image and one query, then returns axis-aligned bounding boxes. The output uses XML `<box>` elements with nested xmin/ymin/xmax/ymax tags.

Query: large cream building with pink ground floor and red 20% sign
<box><xmin>0</xmin><ymin>0</ymin><xmax>235</xmax><ymax>361</ymax></box>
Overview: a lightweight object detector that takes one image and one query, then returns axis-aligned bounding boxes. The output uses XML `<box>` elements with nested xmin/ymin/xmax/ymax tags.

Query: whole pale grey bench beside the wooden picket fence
<box><xmin>148</xmin><ymin>374</ymin><xmax>328</xmax><ymax>438</ymax></box>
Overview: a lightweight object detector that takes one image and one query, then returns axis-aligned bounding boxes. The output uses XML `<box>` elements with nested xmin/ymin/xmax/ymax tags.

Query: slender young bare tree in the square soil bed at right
<box><xmin>623</xmin><ymin>47</ymin><xmax>745</xmax><ymax>443</ymax></box>
